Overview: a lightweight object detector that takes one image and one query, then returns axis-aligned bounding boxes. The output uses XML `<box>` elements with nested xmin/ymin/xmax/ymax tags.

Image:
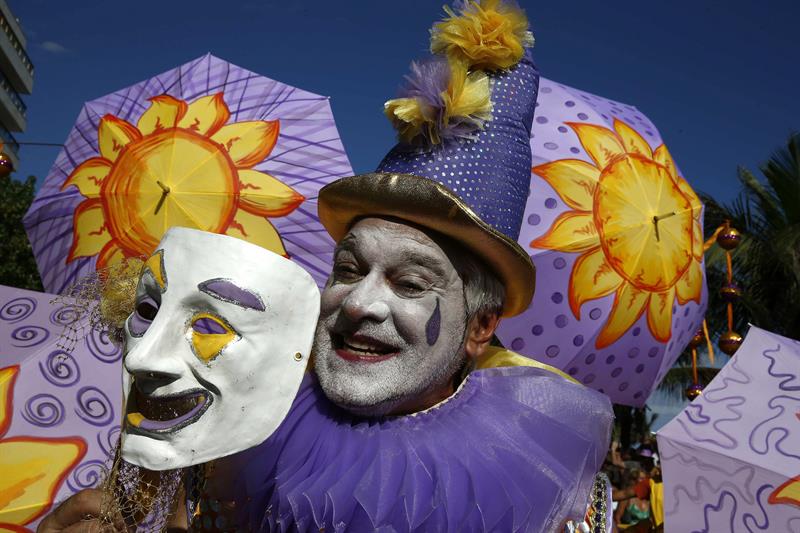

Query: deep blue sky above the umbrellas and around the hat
<box><xmin>8</xmin><ymin>0</ymin><xmax>800</xmax><ymax>203</ymax></box>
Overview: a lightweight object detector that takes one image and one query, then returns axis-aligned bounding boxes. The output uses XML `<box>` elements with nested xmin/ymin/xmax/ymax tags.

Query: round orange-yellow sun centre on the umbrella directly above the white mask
<box><xmin>100</xmin><ymin>128</ymin><xmax>239</xmax><ymax>255</ymax></box>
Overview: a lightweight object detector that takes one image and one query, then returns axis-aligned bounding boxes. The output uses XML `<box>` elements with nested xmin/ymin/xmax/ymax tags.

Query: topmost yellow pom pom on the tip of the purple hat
<box><xmin>431</xmin><ymin>0</ymin><xmax>533</xmax><ymax>70</ymax></box>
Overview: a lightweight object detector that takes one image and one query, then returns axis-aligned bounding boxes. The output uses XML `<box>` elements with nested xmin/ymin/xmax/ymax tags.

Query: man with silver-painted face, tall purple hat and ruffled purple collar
<box><xmin>42</xmin><ymin>0</ymin><xmax>611</xmax><ymax>531</ymax></box>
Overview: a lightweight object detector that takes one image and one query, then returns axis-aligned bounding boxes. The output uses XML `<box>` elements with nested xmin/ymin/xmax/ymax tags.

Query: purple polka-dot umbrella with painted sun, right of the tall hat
<box><xmin>498</xmin><ymin>78</ymin><xmax>707</xmax><ymax>406</ymax></box>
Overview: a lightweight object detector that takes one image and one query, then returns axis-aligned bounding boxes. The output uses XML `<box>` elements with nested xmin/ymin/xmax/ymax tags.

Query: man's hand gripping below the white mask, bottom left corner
<box><xmin>36</xmin><ymin>489</ymin><xmax>126</xmax><ymax>533</ymax></box>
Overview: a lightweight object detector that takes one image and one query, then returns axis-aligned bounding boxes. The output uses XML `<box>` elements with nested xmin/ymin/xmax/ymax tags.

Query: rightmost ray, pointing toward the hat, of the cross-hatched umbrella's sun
<box><xmin>239</xmin><ymin>169</ymin><xmax>305</xmax><ymax>217</ymax></box>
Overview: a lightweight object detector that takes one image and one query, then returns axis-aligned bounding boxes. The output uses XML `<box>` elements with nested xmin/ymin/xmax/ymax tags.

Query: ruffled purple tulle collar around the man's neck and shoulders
<box><xmin>231</xmin><ymin>367</ymin><xmax>612</xmax><ymax>533</ymax></box>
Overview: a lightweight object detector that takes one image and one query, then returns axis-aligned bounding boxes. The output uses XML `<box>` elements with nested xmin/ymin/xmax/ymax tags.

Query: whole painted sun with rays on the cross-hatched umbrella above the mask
<box><xmin>62</xmin><ymin>93</ymin><xmax>305</xmax><ymax>269</ymax></box>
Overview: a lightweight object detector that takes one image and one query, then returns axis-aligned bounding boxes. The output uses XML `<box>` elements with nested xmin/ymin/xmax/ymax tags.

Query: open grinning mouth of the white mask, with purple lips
<box><xmin>125</xmin><ymin>382</ymin><xmax>214</xmax><ymax>436</ymax></box>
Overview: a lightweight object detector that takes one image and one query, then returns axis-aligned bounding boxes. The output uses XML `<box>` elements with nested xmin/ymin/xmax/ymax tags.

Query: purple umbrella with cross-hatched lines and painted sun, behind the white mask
<box><xmin>25</xmin><ymin>55</ymin><xmax>352</xmax><ymax>293</ymax></box>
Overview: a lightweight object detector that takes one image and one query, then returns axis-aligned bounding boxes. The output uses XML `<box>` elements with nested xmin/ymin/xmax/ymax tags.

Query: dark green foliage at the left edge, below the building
<box><xmin>0</xmin><ymin>176</ymin><xmax>42</xmax><ymax>291</ymax></box>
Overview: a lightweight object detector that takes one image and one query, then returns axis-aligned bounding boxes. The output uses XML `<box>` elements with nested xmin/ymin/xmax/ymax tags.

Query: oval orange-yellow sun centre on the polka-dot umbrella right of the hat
<box><xmin>593</xmin><ymin>154</ymin><xmax>694</xmax><ymax>292</ymax></box>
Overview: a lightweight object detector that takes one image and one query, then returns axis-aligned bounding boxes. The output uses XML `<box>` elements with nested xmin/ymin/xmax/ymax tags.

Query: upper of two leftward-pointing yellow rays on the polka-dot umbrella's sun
<box><xmin>531</xmin><ymin>159</ymin><xmax>600</xmax><ymax>211</ymax></box>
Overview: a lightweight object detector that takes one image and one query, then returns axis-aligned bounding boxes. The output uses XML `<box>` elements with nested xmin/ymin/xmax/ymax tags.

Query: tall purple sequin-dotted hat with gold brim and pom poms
<box><xmin>319</xmin><ymin>0</ymin><xmax>539</xmax><ymax>316</ymax></box>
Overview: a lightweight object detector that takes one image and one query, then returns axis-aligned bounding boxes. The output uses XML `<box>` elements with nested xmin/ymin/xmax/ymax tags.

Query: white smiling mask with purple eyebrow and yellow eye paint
<box><xmin>122</xmin><ymin>228</ymin><xmax>319</xmax><ymax>470</ymax></box>
